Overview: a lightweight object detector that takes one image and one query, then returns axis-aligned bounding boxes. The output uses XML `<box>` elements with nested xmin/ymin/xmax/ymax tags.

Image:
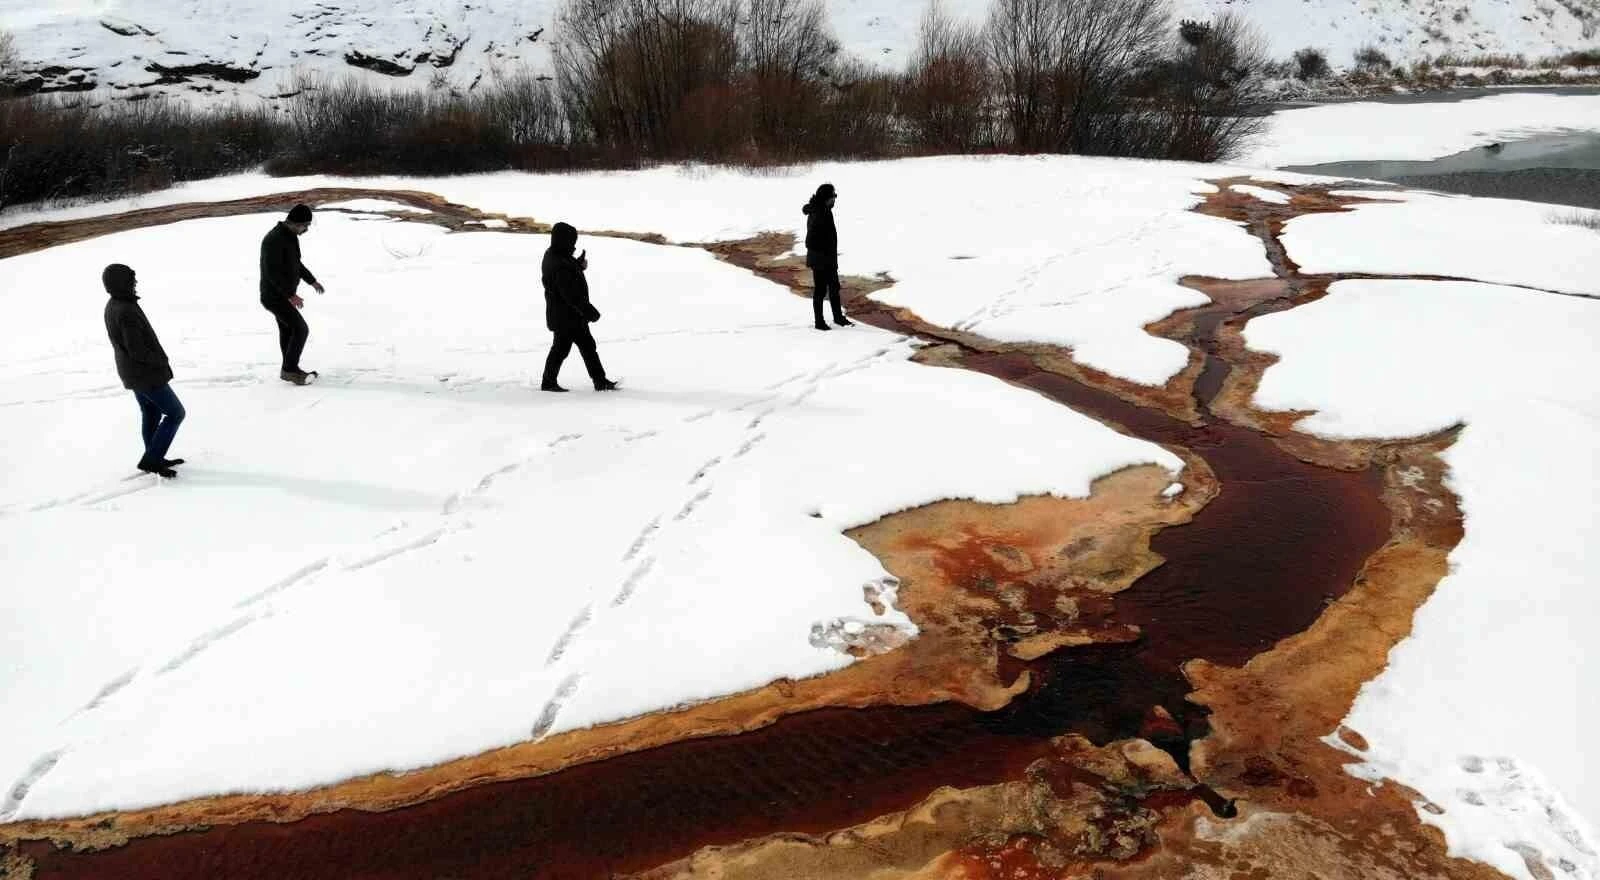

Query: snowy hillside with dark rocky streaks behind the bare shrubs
<box><xmin>0</xmin><ymin>0</ymin><xmax>1600</xmax><ymax>96</ymax></box>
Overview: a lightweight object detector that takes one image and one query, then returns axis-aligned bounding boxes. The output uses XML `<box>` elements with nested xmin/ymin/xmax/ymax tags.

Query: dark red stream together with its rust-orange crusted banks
<box><xmin>0</xmin><ymin>181</ymin><xmax>1493</xmax><ymax>878</ymax></box>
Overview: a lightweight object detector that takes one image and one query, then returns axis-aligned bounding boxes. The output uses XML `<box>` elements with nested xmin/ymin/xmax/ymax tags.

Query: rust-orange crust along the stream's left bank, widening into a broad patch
<box><xmin>0</xmin><ymin>466</ymin><xmax>1216</xmax><ymax>848</ymax></box>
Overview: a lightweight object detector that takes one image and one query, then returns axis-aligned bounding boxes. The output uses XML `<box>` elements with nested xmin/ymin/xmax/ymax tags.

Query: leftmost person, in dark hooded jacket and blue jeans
<box><xmin>101</xmin><ymin>262</ymin><xmax>186</xmax><ymax>478</ymax></box>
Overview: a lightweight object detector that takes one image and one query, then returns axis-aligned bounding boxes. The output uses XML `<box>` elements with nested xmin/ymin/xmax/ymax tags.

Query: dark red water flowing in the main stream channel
<box><xmin>15</xmin><ymin>291</ymin><xmax>1389</xmax><ymax>880</ymax></box>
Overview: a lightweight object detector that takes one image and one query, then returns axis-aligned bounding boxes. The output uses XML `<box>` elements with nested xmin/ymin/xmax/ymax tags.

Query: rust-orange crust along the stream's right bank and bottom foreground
<box><xmin>604</xmin><ymin>181</ymin><xmax>1501</xmax><ymax>880</ymax></box>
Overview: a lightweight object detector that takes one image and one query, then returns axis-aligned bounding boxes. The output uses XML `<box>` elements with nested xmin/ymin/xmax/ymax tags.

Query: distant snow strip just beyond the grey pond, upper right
<box><xmin>1238</xmin><ymin>93</ymin><xmax>1600</xmax><ymax>168</ymax></box>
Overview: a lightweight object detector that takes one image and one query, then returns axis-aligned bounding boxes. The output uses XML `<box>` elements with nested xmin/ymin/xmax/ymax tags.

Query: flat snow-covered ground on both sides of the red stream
<box><xmin>0</xmin><ymin>150</ymin><xmax>1600</xmax><ymax>877</ymax></box>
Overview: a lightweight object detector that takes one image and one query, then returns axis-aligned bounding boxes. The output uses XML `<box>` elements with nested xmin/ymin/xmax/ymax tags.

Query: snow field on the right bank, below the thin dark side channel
<box><xmin>1245</xmin><ymin>281</ymin><xmax>1600</xmax><ymax>880</ymax></box>
